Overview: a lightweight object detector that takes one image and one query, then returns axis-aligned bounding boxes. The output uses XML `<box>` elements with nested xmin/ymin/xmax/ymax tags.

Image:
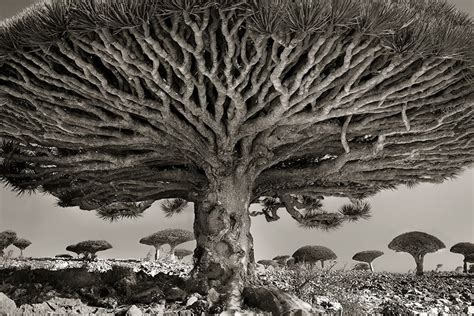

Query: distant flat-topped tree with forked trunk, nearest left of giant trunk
<box><xmin>140</xmin><ymin>229</ymin><xmax>195</xmax><ymax>260</ymax></box>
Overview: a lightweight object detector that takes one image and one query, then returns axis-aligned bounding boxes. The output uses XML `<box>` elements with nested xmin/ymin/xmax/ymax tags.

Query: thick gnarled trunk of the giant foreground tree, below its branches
<box><xmin>193</xmin><ymin>175</ymin><xmax>254</xmax><ymax>312</ymax></box>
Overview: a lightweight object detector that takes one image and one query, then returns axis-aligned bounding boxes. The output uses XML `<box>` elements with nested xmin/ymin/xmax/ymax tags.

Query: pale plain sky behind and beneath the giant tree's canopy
<box><xmin>0</xmin><ymin>0</ymin><xmax>474</xmax><ymax>272</ymax></box>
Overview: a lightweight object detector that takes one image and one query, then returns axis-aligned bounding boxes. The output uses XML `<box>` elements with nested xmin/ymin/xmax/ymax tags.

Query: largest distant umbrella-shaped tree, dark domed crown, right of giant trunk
<box><xmin>388</xmin><ymin>231</ymin><xmax>446</xmax><ymax>275</ymax></box>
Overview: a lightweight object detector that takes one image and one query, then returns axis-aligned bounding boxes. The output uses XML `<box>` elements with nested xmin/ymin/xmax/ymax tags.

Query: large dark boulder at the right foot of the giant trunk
<box><xmin>242</xmin><ymin>287</ymin><xmax>325</xmax><ymax>315</ymax></box>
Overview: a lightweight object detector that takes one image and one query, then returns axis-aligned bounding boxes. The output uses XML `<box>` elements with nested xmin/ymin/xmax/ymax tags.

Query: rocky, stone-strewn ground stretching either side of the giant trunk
<box><xmin>0</xmin><ymin>259</ymin><xmax>474</xmax><ymax>315</ymax></box>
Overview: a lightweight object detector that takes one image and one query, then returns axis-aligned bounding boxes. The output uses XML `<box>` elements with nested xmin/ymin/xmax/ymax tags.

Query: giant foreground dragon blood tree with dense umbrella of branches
<box><xmin>0</xmin><ymin>0</ymin><xmax>474</xmax><ymax>308</ymax></box>
